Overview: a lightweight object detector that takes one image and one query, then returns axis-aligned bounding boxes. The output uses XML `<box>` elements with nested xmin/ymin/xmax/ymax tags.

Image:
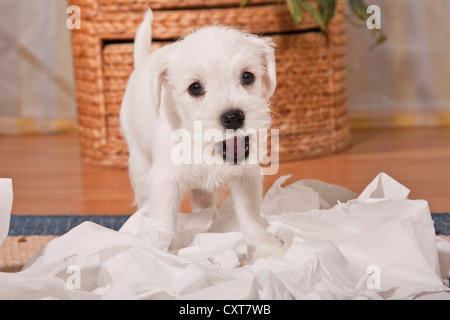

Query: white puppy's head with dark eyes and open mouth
<box><xmin>153</xmin><ymin>27</ymin><xmax>276</xmax><ymax>163</ymax></box>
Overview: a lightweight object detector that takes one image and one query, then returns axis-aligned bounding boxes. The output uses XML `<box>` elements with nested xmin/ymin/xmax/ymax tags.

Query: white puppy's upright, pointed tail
<box><xmin>134</xmin><ymin>8</ymin><xmax>153</xmax><ymax>69</ymax></box>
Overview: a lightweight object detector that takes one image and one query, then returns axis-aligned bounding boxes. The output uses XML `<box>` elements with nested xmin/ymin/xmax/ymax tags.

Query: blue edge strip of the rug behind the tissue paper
<box><xmin>9</xmin><ymin>213</ymin><xmax>450</xmax><ymax>236</ymax></box>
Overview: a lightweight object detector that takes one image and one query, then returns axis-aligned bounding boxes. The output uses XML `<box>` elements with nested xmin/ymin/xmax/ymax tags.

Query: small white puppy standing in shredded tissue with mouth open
<box><xmin>120</xmin><ymin>10</ymin><xmax>281</xmax><ymax>258</ymax></box>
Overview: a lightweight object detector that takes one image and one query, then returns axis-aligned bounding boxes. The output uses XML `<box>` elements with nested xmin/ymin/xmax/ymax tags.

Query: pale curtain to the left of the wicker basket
<box><xmin>0</xmin><ymin>0</ymin><xmax>76</xmax><ymax>134</ymax></box>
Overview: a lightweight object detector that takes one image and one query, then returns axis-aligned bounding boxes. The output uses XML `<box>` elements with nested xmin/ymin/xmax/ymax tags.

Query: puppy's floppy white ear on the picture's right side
<box><xmin>253</xmin><ymin>36</ymin><xmax>277</xmax><ymax>99</ymax></box>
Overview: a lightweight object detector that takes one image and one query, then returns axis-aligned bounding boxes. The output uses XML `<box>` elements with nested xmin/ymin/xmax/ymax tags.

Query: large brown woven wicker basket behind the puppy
<box><xmin>70</xmin><ymin>0</ymin><xmax>350</xmax><ymax>168</ymax></box>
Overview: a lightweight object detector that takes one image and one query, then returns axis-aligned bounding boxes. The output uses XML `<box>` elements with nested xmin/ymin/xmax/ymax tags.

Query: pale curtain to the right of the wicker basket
<box><xmin>347</xmin><ymin>0</ymin><xmax>450</xmax><ymax>127</ymax></box>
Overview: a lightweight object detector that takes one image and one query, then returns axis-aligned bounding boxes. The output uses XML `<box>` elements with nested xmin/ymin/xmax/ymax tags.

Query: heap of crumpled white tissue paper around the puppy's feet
<box><xmin>0</xmin><ymin>173</ymin><xmax>450</xmax><ymax>299</ymax></box>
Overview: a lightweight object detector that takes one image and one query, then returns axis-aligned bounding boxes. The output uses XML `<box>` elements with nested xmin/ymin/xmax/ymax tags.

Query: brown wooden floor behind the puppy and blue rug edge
<box><xmin>0</xmin><ymin>128</ymin><xmax>450</xmax><ymax>215</ymax></box>
